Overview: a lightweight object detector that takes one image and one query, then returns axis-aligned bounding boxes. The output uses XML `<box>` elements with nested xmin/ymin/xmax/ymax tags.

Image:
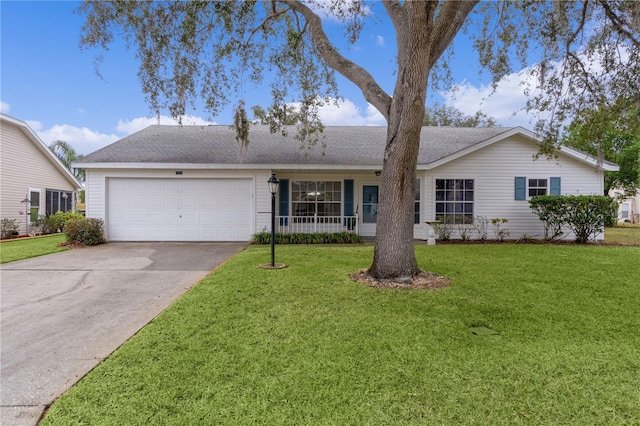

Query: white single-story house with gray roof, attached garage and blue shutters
<box><xmin>74</xmin><ymin>125</ymin><xmax>617</xmax><ymax>241</ymax></box>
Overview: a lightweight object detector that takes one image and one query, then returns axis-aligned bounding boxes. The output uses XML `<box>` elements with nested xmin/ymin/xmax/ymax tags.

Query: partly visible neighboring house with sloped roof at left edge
<box><xmin>0</xmin><ymin>114</ymin><xmax>81</xmax><ymax>235</ymax></box>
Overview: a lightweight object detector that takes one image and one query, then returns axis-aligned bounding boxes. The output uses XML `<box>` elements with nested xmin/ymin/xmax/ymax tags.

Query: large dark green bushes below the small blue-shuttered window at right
<box><xmin>529</xmin><ymin>195</ymin><xmax>618</xmax><ymax>243</ymax></box>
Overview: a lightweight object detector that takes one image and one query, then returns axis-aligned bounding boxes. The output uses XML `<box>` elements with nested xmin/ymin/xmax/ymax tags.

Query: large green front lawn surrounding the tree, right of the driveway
<box><xmin>42</xmin><ymin>244</ymin><xmax>640</xmax><ymax>425</ymax></box>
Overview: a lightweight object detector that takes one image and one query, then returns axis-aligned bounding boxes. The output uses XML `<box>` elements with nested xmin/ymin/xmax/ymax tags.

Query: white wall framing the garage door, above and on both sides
<box><xmin>85</xmin><ymin>168</ymin><xmax>271</xmax><ymax>239</ymax></box>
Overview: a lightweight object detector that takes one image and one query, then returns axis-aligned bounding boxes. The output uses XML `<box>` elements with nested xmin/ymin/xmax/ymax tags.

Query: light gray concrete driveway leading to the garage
<box><xmin>0</xmin><ymin>243</ymin><xmax>247</xmax><ymax>426</ymax></box>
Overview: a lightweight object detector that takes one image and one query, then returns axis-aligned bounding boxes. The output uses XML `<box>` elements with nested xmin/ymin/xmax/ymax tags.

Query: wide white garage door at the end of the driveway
<box><xmin>107</xmin><ymin>178</ymin><xmax>253</xmax><ymax>241</ymax></box>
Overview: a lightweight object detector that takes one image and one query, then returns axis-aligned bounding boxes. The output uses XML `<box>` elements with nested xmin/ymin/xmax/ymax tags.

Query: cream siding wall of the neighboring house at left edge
<box><xmin>0</xmin><ymin>120</ymin><xmax>76</xmax><ymax>235</ymax></box>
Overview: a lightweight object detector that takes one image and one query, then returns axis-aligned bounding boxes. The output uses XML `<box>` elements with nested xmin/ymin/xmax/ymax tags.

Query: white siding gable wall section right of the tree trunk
<box><xmin>425</xmin><ymin>136</ymin><xmax>604</xmax><ymax>239</ymax></box>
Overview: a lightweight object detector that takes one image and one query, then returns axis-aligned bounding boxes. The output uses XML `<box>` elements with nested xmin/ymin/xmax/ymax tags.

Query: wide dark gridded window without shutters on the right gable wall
<box><xmin>436</xmin><ymin>179</ymin><xmax>474</xmax><ymax>223</ymax></box>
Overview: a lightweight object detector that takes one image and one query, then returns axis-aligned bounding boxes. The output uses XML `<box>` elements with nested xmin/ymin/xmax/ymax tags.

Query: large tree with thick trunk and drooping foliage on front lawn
<box><xmin>79</xmin><ymin>0</ymin><xmax>640</xmax><ymax>278</ymax></box>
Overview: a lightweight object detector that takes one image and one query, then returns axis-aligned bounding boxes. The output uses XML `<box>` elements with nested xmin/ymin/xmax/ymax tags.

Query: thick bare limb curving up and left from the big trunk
<box><xmin>284</xmin><ymin>0</ymin><xmax>391</xmax><ymax>120</ymax></box>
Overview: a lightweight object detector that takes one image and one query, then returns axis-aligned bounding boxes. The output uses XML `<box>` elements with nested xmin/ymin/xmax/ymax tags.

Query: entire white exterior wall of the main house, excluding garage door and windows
<box><xmin>86</xmin><ymin>136</ymin><xmax>604</xmax><ymax>243</ymax></box>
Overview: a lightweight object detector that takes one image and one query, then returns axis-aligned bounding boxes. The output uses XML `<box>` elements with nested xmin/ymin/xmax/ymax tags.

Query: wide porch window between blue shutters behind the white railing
<box><xmin>291</xmin><ymin>181</ymin><xmax>342</xmax><ymax>217</ymax></box>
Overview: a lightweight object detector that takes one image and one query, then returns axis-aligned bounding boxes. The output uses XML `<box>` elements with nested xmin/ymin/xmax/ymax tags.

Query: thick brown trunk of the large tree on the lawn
<box><xmin>369</xmin><ymin>3</ymin><xmax>434</xmax><ymax>281</ymax></box>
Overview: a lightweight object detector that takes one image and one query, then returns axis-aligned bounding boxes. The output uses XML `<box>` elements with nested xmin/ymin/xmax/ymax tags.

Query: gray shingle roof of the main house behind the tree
<box><xmin>79</xmin><ymin>125</ymin><xmax>511</xmax><ymax>166</ymax></box>
